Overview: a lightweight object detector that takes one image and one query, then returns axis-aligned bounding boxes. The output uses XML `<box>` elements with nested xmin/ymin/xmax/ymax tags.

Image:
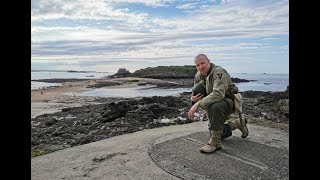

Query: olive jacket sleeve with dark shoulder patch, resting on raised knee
<box><xmin>199</xmin><ymin>68</ymin><xmax>229</xmax><ymax>109</ymax></box>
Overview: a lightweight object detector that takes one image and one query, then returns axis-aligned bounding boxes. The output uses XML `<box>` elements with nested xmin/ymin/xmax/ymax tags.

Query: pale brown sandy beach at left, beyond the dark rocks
<box><xmin>31</xmin><ymin>77</ymin><xmax>189</xmax><ymax>118</ymax></box>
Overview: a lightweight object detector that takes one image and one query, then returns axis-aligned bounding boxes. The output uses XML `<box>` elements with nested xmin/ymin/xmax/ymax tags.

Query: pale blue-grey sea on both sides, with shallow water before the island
<box><xmin>31</xmin><ymin>70</ymin><xmax>289</xmax><ymax>97</ymax></box>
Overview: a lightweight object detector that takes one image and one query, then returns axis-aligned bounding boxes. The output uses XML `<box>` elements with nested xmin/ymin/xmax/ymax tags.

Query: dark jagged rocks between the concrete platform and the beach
<box><xmin>31</xmin><ymin>86</ymin><xmax>289</xmax><ymax>157</ymax></box>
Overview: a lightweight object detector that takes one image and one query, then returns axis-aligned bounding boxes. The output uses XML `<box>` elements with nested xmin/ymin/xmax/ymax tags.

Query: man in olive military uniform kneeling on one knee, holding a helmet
<box><xmin>188</xmin><ymin>54</ymin><xmax>249</xmax><ymax>153</ymax></box>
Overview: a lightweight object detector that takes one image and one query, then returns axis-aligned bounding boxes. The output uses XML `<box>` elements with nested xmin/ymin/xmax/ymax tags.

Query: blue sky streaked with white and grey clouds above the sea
<box><xmin>31</xmin><ymin>0</ymin><xmax>289</xmax><ymax>74</ymax></box>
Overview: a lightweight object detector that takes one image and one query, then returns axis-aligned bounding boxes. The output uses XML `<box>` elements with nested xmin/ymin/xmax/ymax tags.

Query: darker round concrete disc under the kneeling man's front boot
<box><xmin>149</xmin><ymin>132</ymin><xmax>289</xmax><ymax>180</ymax></box>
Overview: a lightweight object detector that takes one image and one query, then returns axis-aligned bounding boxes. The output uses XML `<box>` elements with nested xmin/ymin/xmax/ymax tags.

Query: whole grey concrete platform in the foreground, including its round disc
<box><xmin>31</xmin><ymin>121</ymin><xmax>289</xmax><ymax>180</ymax></box>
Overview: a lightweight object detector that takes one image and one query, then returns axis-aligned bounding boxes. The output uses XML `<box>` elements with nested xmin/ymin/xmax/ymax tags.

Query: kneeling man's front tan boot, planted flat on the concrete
<box><xmin>200</xmin><ymin>130</ymin><xmax>223</xmax><ymax>153</ymax></box>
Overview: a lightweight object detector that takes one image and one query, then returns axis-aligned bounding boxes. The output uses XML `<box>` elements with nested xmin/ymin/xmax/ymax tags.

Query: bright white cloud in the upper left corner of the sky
<box><xmin>31</xmin><ymin>0</ymin><xmax>147</xmax><ymax>23</ymax></box>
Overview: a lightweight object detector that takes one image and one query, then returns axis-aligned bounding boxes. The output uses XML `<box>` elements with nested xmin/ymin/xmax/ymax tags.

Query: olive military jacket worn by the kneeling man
<box><xmin>194</xmin><ymin>63</ymin><xmax>234</xmax><ymax>109</ymax></box>
